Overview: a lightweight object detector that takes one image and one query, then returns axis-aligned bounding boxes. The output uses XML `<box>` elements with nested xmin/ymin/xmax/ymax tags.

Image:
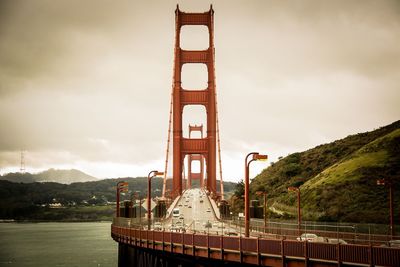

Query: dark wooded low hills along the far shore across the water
<box><xmin>0</xmin><ymin>177</ymin><xmax>235</xmax><ymax>221</ymax></box>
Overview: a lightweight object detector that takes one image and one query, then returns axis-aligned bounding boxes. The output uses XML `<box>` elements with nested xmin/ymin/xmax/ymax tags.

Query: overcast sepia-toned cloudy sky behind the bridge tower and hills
<box><xmin>0</xmin><ymin>0</ymin><xmax>400</xmax><ymax>181</ymax></box>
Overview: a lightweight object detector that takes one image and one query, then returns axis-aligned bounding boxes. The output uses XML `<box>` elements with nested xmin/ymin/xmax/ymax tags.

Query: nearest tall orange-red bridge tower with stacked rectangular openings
<box><xmin>172</xmin><ymin>6</ymin><xmax>217</xmax><ymax>195</ymax></box>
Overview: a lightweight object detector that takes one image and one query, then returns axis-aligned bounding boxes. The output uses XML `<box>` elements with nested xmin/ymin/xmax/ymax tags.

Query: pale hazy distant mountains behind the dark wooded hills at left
<box><xmin>0</xmin><ymin>169</ymin><xmax>98</xmax><ymax>184</ymax></box>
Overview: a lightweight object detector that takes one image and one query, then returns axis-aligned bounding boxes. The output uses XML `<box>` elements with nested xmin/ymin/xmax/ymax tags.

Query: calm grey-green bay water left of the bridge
<box><xmin>0</xmin><ymin>222</ymin><xmax>118</xmax><ymax>267</ymax></box>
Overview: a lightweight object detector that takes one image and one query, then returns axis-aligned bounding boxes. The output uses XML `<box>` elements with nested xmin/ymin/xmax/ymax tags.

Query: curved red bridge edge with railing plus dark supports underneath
<box><xmin>111</xmin><ymin>225</ymin><xmax>400</xmax><ymax>267</ymax></box>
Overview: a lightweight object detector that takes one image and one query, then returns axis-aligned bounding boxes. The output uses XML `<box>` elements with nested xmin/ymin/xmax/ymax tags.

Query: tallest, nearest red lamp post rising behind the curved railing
<box><xmin>244</xmin><ymin>152</ymin><xmax>268</xmax><ymax>237</ymax></box>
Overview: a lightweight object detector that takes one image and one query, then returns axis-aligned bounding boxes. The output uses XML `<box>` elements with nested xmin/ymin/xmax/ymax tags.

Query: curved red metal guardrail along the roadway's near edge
<box><xmin>111</xmin><ymin>224</ymin><xmax>400</xmax><ymax>266</ymax></box>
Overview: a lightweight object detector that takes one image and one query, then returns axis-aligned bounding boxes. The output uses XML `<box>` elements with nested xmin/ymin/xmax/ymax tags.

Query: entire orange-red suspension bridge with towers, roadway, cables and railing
<box><xmin>111</xmin><ymin>6</ymin><xmax>400</xmax><ymax>266</ymax></box>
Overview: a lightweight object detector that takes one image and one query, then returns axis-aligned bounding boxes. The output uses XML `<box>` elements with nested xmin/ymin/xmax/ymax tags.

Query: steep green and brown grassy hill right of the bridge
<box><xmin>250</xmin><ymin>121</ymin><xmax>400</xmax><ymax>223</ymax></box>
